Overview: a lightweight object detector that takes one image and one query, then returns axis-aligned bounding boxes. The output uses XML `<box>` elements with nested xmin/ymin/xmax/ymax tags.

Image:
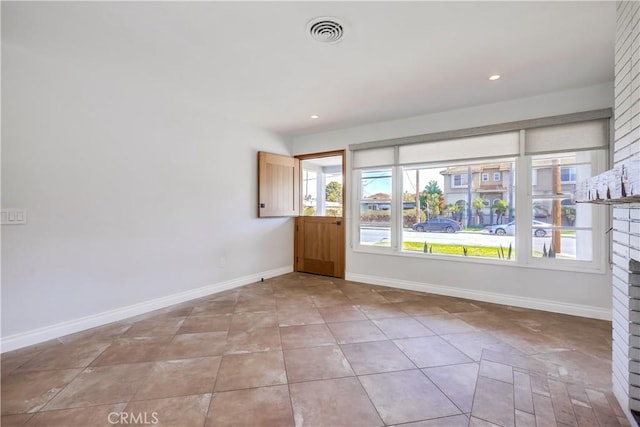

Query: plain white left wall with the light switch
<box><xmin>2</xmin><ymin>44</ymin><xmax>293</xmax><ymax>351</ymax></box>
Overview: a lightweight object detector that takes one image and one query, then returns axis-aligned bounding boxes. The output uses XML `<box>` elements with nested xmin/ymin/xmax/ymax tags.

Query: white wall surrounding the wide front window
<box><xmin>293</xmin><ymin>83</ymin><xmax>613</xmax><ymax>318</ymax></box>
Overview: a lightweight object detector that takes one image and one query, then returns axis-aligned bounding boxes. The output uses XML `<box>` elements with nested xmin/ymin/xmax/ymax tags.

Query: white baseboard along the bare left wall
<box><xmin>0</xmin><ymin>267</ymin><xmax>293</xmax><ymax>353</ymax></box>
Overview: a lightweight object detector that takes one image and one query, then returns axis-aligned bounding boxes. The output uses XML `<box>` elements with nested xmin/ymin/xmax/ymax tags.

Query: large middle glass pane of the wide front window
<box><xmin>400</xmin><ymin>158</ymin><xmax>515</xmax><ymax>261</ymax></box>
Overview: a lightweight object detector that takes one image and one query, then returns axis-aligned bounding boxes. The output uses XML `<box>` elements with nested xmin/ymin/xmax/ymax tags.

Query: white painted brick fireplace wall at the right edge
<box><xmin>612</xmin><ymin>1</ymin><xmax>640</xmax><ymax>411</ymax></box>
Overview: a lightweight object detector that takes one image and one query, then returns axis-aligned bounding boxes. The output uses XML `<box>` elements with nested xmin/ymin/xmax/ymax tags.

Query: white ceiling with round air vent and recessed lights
<box><xmin>2</xmin><ymin>1</ymin><xmax>616</xmax><ymax>135</ymax></box>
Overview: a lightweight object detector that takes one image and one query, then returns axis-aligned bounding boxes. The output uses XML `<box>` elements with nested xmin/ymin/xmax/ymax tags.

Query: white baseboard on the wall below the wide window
<box><xmin>346</xmin><ymin>272</ymin><xmax>611</xmax><ymax>320</ymax></box>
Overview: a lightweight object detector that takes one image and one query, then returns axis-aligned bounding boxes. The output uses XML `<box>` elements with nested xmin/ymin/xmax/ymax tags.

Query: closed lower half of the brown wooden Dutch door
<box><xmin>295</xmin><ymin>216</ymin><xmax>345</xmax><ymax>278</ymax></box>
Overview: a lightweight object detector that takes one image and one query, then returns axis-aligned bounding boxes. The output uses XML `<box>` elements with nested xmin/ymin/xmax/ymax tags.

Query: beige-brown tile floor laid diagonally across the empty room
<box><xmin>1</xmin><ymin>273</ymin><xmax>629</xmax><ymax>427</ymax></box>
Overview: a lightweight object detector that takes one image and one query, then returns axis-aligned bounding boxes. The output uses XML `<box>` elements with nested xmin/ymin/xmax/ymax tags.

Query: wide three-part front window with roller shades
<box><xmin>352</xmin><ymin>112</ymin><xmax>609</xmax><ymax>272</ymax></box>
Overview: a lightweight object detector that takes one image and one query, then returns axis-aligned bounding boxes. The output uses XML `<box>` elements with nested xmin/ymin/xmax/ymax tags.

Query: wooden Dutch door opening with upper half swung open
<box><xmin>294</xmin><ymin>151</ymin><xmax>345</xmax><ymax>278</ymax></box>
